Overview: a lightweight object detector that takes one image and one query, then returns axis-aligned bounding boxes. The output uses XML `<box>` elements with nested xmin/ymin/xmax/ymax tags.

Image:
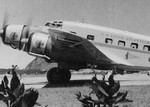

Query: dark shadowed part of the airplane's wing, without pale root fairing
<box><xmin>49</xmin><ymin>29</ymin><xmax>112</xmax><ymax>63</ymax></box>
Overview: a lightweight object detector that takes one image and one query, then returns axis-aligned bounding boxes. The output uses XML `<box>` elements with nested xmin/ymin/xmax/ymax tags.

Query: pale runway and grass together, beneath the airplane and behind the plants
<box><xmin>0</xmin><ymin>74</ymin><xmax>150</xmax><ymax>107</ymax></box>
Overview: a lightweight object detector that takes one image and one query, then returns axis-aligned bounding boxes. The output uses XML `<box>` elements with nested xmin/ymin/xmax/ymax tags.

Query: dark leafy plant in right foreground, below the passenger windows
<box><xmin>76</xmin><ymin>75</ymin><xmax>132</xmax><ymax>107</ymax></box>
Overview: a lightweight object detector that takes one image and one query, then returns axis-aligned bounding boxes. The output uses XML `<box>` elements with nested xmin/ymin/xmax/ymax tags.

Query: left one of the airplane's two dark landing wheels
<box><xmin>47</xmin><ymin>67</ymin><xmax>61</xmax><ymax>83</ymax></box>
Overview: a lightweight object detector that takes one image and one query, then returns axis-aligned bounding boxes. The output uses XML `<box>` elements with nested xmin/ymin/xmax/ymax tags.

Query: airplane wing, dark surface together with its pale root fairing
<box><xmin>49</xmin><ymin>29</ymin><xmax>136</xmax><ymax>70</ymax></box>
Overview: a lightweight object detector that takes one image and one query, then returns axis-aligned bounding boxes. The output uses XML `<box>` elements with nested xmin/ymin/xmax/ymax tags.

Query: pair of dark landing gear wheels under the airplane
<box><xmin>47</xmin><ymin>67</ymin><xmax>71</xmax><ymax>84</ymax></box>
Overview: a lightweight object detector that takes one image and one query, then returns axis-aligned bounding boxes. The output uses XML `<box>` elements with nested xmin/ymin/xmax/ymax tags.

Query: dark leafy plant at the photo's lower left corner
<box><xmin>0</xmin><ymin>66</ymin><xmax>39</xmax><ymax>107</ymax></box>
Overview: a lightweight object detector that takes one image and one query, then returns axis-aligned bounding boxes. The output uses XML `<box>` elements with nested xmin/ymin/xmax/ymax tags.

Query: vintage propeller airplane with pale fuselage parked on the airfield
<box><xmin>1</xmin><ymin>16</ymin><xmax>150</xmax><ymax>83</ymax></box>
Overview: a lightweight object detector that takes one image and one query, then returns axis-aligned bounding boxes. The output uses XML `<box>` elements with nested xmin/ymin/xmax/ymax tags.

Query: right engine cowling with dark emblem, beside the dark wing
<box><xmin>27</xmin><ymin>32</ymin><xmax>50</xmax><ymax>59</ymax></box>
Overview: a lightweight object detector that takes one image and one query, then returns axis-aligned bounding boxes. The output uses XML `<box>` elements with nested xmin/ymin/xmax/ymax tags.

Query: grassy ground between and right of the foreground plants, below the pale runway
<box><xmin>38</xmin><ymin>86</ymin><xmax>150</xmax><ymax>107</ymax></box>
